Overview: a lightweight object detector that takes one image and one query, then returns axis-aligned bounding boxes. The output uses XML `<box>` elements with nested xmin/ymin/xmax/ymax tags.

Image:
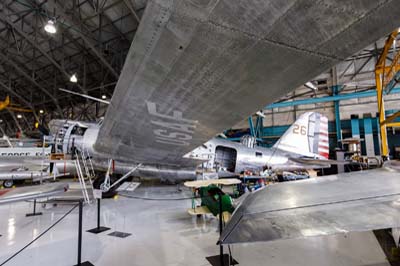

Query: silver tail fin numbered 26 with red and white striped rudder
<box><xmin>274</xmin><ymin>112</ymin><xmax>329</xmax><ymax>159</ymax></box>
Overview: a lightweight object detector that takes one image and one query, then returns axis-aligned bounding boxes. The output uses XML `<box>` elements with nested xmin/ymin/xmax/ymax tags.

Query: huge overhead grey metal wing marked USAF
<box><xmin>95</xmin><ymin>0</ymin><xmax>400</xmax><ymax>167</ymax></box>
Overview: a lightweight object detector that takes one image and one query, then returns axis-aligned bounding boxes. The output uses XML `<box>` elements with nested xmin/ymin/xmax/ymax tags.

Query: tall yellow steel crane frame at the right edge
<box><xmin>375</xmin><ymin>28</ymin><xmax>400</xmax><ymax>157</ymax></box>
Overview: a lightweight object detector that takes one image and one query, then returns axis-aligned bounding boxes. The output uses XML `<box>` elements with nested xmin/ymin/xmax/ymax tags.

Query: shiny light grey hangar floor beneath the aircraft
<box><xmin>0</xmin><ymin>187</ymin><xmax>389</xmax><ymax>266</ymax></box>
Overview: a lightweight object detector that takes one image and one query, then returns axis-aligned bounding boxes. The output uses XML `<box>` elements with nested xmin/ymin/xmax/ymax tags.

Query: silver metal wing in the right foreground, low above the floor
<box><xmin>220</xmin><ymin>168</ymin><xmax>400</xmax><ymax>244</ymax></box>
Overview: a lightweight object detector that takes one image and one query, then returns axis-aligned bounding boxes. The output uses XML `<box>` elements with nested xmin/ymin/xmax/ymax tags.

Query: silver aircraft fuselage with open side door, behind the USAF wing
<box><xmin>46</xmin><ymin>121</ymin><xmax>318</xmax><ymax>180</ymax></box>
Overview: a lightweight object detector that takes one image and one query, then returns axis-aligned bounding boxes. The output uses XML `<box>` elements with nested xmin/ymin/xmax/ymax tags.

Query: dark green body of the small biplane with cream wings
<box><xmin>199</xmin><ymin>185</ymin><xmax>235</xmax><ymax>216</ymax></box>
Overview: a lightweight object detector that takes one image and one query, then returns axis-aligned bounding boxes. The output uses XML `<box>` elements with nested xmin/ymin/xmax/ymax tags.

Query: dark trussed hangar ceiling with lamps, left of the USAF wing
<box><xmin>0</xmin><ymin>0</ymin><xmax>145</xmax><ymax>130</ymax></box>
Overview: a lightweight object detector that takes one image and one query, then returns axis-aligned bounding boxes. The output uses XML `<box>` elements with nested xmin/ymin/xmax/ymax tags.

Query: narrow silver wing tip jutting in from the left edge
<box><xmin>0</xmin><ymin>184</ymin><xmax>68</xmax><ymax>204</ymax></box>
